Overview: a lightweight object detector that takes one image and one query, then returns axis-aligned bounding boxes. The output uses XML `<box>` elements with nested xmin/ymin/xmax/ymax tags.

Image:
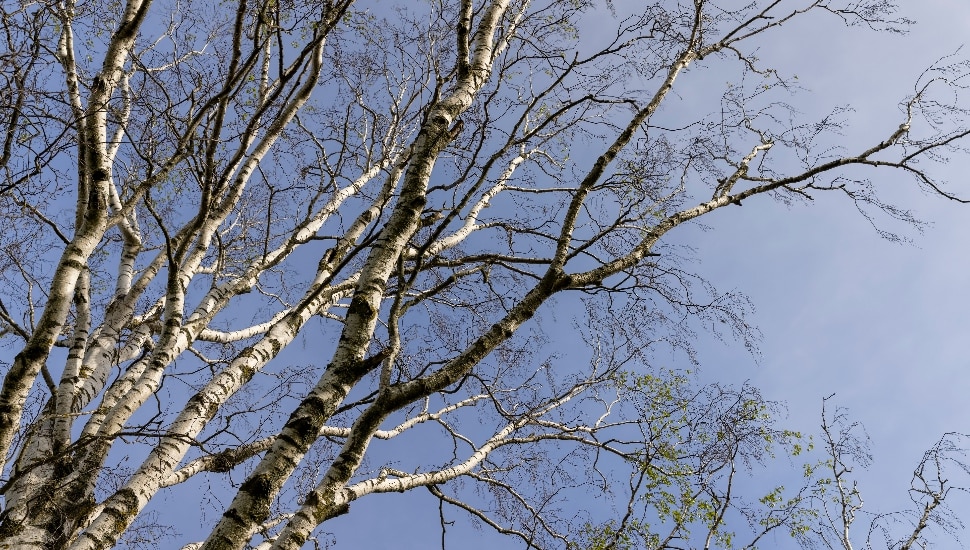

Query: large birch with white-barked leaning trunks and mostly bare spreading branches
<box><xmin>0</xmin><ymin>0</ymin><xmax>970</xmax><ymax>550</ymax></box>
